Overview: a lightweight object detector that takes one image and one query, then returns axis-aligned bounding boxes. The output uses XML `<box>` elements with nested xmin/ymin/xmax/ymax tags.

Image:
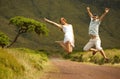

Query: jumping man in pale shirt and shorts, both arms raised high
<box><xmin>83</xmin><ymin>7</ymin><xmax>109</xmax><ymax>60</ymax></box>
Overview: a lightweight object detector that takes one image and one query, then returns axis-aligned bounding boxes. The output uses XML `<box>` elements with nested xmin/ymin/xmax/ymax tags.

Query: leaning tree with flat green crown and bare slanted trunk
<box><xmin>8</xmin><ymin>16</ymin><xmax>48</xmax><ymax>47</ymax></box>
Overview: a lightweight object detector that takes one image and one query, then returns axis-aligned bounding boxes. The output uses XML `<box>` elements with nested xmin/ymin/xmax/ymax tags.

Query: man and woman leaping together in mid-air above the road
<box><xmin>44</xmin><ymin>7</ymin><xmax>109</xmax><ymax>60</ymax></box>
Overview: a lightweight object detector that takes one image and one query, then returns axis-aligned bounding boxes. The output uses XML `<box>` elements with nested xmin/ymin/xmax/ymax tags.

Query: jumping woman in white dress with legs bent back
<box><xmin>44</xmin><ymin>17</ymin><xmax>74</xmax><ymax>54</ymax></box>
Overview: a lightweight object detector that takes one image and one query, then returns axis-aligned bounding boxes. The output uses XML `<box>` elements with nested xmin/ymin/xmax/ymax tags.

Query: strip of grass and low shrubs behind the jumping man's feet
<box><xmin>64</xmin><ymin>49</ymin><xmax>120</xmax><ymax>65</ymax></box>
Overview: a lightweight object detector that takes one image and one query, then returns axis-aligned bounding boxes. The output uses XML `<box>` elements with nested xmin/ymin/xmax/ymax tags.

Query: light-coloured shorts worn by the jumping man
<box><xmin>83</xmin><ymin>36</ymin><xmax>102</xmax><ymax>51</ymax></box>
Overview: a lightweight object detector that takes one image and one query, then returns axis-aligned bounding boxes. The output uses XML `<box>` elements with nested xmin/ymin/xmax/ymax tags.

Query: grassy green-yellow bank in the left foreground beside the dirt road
<box><xmin>0</xmin><ymin>48</ymin><xmax>48</xmax><ymax>79</ymax></box>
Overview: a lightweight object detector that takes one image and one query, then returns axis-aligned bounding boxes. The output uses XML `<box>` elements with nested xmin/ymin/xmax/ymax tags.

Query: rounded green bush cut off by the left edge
<box><xmin>0</xmin><ymin>32</ymin><xmax>10</xmax><ymax>48</ymax></box>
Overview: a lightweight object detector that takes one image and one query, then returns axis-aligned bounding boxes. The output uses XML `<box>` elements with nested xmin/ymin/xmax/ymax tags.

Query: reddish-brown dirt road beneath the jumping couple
<box><xmin>43</xmin><ymin>58</ymin><xmax>120</xmax><ymax>79</ymax></box>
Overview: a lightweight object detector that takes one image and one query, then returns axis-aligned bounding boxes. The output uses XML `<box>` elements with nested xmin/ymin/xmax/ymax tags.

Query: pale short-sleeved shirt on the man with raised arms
<box><xmin>89</xmin><ymin>18</ymin><xmax>101</xmax><ymax>36</ymax></box>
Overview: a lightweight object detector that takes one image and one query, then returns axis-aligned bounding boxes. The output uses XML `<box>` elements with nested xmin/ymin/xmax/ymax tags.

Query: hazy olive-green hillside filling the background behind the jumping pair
<box><xmin>0</xmin><ymin>0</ymin><xmax>120</xmax><ymax>51</ymax></box>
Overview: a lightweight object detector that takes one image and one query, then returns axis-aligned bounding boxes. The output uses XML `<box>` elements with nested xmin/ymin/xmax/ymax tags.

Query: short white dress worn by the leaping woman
<box><xmin>62</xmin><ymin>24</ymin><xmax>74</xmax><ymax>47</ymax></box>
